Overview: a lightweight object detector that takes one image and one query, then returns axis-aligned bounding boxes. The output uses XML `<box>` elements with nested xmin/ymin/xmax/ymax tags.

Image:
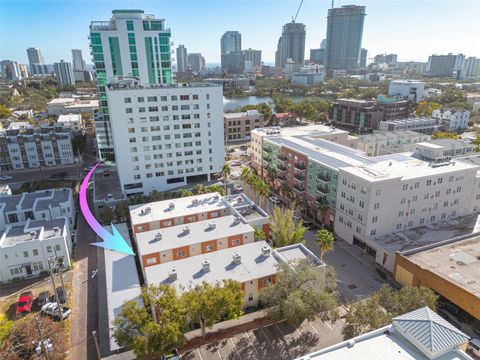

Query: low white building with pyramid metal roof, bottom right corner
<box><xmin>297</xmin><ymin>307</ymin><xmax>473</xmax><ymax>360</ymax></box>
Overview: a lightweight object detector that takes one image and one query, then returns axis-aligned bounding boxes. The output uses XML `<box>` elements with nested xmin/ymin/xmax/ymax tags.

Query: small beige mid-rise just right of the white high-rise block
<box><xmin>223</xmin><ymin>110</ymin><xmax>264</xmax><ymax>144</ymax></box>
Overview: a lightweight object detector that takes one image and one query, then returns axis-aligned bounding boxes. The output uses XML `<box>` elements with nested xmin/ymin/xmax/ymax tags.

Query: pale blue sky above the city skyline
<box><xmin>0</xmin><ymin>0</ymin><xmax>480</xmax><ymax>63</ymax></box>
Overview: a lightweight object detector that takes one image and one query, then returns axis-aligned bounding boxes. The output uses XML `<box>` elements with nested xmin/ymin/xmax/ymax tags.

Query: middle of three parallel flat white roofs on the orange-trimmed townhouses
<box><xmin>136</xmin><ymin>215</ymin><xmax>254</xmax><ymax>255</ymax></box>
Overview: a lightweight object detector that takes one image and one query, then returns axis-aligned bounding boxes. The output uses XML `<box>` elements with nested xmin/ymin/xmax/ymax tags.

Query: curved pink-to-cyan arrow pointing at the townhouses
<box><xmin>80</xmin><ymin>162</ymin><xmax>135</xmax><ymax>255</ymax></box>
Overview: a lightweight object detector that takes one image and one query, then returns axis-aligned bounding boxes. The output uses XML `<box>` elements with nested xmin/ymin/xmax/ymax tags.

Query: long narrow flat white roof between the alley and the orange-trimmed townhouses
<box><xmin>103</xmin><ymin>223</ymin><xmax>143</xmax><ymax>351</ymax></box>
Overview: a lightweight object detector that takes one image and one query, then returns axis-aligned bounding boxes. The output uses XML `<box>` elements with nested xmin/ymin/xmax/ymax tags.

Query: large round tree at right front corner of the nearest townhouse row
<box><xmin>260</xmin><ymin>259</ymin><xmax>339</xmax><ymax>327</ymax></box>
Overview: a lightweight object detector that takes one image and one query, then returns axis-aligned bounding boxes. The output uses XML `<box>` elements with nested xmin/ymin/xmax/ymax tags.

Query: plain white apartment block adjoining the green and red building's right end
<box><xmin>335</xmin><ymin>155</ymin><xmax>480</xmax><ymax>268</ymax></box>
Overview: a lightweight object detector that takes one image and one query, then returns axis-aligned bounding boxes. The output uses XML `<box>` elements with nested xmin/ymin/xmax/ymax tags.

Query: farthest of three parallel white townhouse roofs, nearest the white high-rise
<box><xmin>129</xmin><ymin>193</ymin><xmax>229</xmax><ymax>225</ymax></box>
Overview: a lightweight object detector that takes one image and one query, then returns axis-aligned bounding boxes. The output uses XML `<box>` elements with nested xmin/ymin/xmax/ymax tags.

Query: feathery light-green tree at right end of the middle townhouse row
<box><xmin>271</xmin><ymin>207</ymin><xmax>307</xmax><ymax>246</ymax></box>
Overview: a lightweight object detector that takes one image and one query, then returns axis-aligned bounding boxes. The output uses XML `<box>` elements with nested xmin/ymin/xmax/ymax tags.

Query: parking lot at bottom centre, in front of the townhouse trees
<box><xmin>181</xmin><ymin>319</ymin><xmax>344</xmax><ymax>360</ymax></box>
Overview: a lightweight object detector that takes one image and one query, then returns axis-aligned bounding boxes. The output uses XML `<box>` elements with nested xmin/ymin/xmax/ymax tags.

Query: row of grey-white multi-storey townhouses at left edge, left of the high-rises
<box><xmin>0</xmin><ymin>123</ymin><xmax>74</xmax><ymax>170</ymax></box>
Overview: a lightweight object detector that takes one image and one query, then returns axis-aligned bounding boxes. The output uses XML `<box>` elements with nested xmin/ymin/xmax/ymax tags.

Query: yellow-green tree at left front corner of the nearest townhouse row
<box><xmin>113</xmin><ymin>285</ymin><xmax>187</xmax><ymax>359</ymax></box>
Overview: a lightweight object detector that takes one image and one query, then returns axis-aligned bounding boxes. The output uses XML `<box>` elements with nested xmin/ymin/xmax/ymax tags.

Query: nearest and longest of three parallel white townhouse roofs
<box><xmin>145</xmin><ymin>241</ymin><xmax>323</xmax><ymax>289</ymax></box>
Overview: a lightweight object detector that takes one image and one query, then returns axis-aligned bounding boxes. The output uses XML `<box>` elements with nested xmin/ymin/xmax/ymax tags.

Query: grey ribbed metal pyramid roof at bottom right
<box><xmin>393</xmin><ymin>306</ymin><xmax>469</xmax><ymax>355</ymax></box>
